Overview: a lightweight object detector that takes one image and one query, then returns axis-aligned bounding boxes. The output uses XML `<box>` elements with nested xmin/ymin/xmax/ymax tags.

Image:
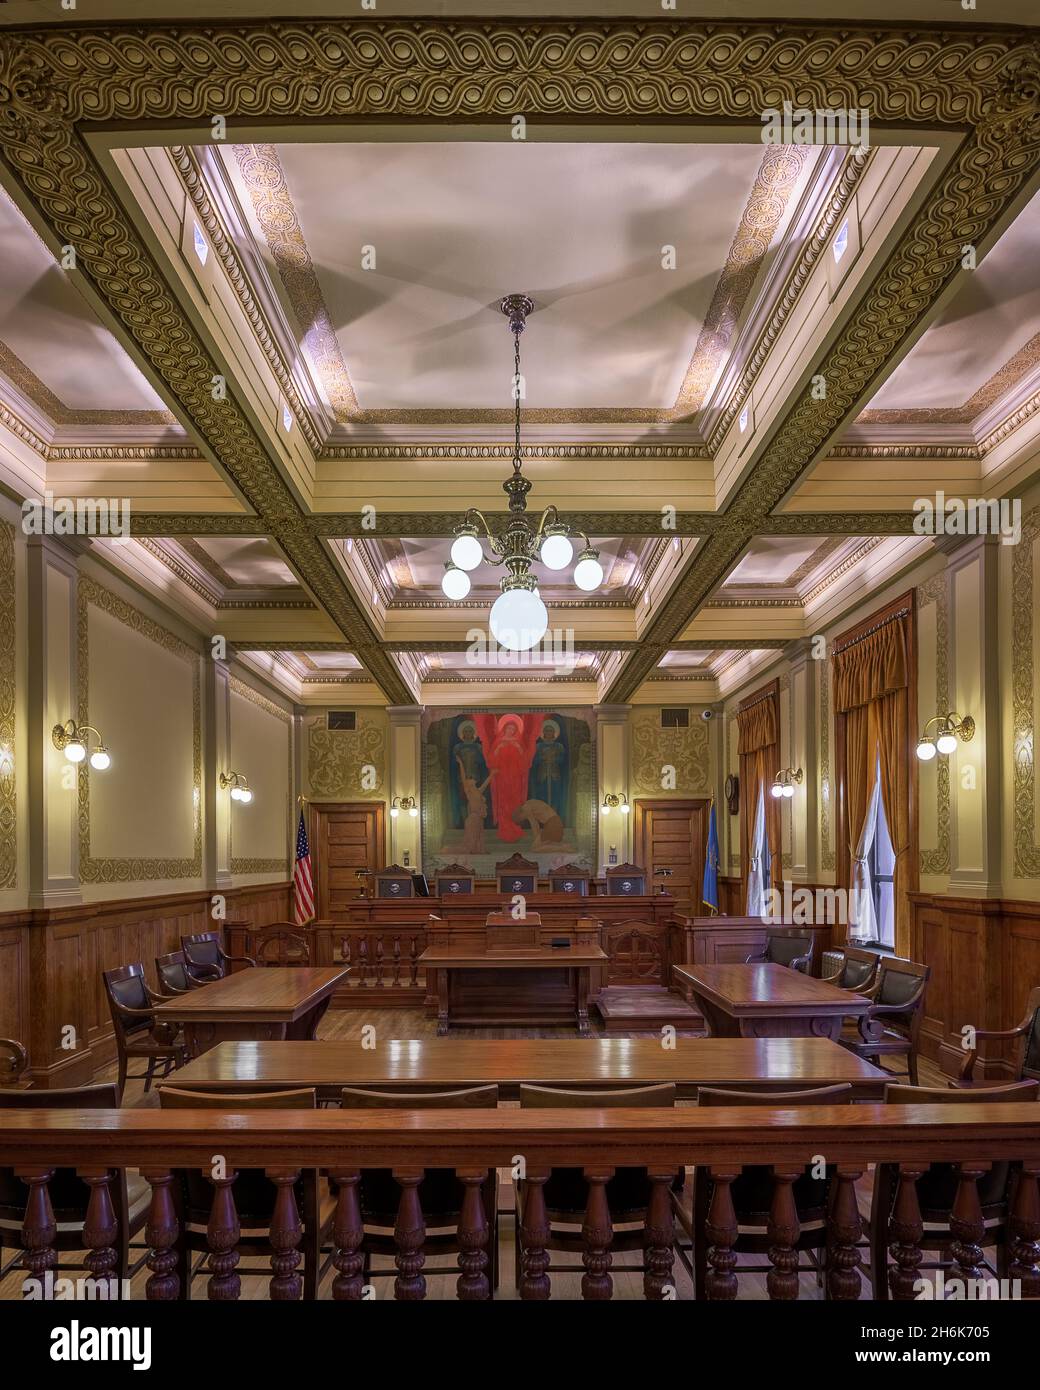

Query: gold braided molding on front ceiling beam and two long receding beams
<box><xmin>0</xmin><ymin>19</ymin><xmax>1040</xmax><ymax>703</ymax></box>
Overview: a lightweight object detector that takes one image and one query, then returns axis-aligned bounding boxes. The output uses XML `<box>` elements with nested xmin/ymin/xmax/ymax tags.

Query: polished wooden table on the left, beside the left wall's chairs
<box><xmin>156</xmin><ymin>966</ymin><xmax>348</xmax><ymax>1052</ymax></box>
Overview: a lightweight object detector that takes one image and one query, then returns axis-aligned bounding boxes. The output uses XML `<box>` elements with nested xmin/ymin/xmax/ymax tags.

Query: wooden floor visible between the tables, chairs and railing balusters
<box><xmin>0</xmin><ymin>1009</ymin><xmax>947</xmax><ymax>1300</ymax></box>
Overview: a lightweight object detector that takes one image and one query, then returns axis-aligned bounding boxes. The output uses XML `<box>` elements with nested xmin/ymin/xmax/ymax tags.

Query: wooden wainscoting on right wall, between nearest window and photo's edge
<box><xmin>911</xmin><ymin>892</ymin><xmax>1040</xmax><ymax>1080</ymax></box>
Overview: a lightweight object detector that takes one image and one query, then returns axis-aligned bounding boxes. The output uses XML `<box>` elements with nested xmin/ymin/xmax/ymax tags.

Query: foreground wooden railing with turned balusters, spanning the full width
<box><xmin>0</xmin><ymin>1104</ymin><xmax>1040</xmax><ymax>1301</ymax></box>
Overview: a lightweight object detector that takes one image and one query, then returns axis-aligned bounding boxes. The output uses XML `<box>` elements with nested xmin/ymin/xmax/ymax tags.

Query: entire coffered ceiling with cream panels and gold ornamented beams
<box><xmin>0</xmin><ymin>10</ymin><xmax>1040</xmax><ymax>703</ymax></box>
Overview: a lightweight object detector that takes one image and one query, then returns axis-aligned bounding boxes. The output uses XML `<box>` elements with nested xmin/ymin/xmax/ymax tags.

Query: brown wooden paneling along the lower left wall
<box><xmin>0</xmin><ymin>883</ymin><xmax>292</xmax><ymax>1086</ymax></box>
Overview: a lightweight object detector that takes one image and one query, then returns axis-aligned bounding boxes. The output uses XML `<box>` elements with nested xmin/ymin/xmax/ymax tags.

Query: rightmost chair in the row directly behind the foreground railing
<box><xmin>869</xmin><ymin>1080</ymin><xmax>1040</xmax><ymax>1300</ymax></box>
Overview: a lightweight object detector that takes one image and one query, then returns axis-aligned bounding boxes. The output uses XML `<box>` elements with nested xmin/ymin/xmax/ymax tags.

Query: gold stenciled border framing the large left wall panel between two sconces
<box><xmin>76</xmin><ymin>575</ymin><xmax>202</xmax><ymax>883</ymax></box>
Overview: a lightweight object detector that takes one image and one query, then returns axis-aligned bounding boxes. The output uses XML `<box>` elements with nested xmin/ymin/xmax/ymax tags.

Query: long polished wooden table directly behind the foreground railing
<box><xmin>166</xmin><ymin>1038</ymin><xmax>890</xmax><ymax>1101</ymax></box>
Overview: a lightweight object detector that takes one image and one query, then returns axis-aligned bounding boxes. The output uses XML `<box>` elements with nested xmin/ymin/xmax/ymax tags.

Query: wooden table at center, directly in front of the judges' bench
<box><xmin>419</xmin><ymin>945</ymin><xmax>606</xmax><ymax>1037</ymax></box>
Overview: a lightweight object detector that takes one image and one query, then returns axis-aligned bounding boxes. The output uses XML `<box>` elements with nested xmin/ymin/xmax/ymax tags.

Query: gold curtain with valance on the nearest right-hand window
<box><xmin>834</xmin><ymin>616</ymin><xmax>911</xmax><ymax>949</ymax></box>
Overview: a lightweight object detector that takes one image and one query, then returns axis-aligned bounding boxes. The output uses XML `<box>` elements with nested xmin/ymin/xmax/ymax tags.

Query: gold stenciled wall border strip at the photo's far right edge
<box><xmin>1011</xmin><ymin>507</ymin><xmax>1040</xmax><ymax>878</ymax></box>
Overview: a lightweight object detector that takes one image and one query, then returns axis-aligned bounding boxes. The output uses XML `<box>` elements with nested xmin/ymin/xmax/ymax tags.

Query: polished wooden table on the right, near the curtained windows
<box><xmin>673</xmin><ymin>965</ymin><xmax>870</xmax><ymax>1040</ymax></box>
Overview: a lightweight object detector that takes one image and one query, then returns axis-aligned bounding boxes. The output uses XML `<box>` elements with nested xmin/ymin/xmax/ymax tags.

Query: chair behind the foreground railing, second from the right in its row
<box><xmin>672</xmin><ymin>1086</ymin><xmax>852</xmax><ymax>1298</ymax></box>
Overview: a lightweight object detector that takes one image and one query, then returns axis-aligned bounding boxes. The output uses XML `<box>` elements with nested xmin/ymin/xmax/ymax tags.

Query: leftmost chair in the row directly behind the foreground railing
<box><xmin>0</xmin><ymin>1081</ymin><xmax>152</xmax><ymax>1279</ymax></box>
